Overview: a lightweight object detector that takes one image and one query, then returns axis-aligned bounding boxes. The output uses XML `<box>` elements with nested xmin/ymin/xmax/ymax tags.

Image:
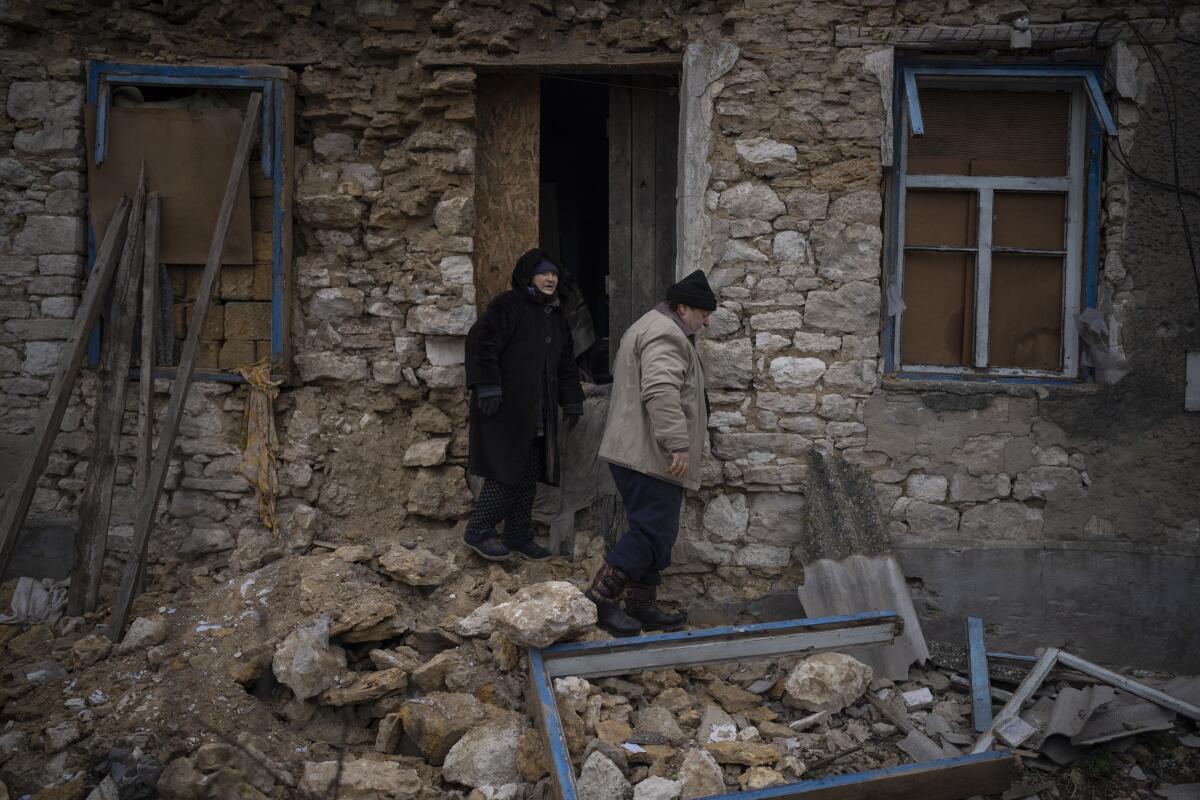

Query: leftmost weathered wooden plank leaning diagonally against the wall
<box><xmin>0</xmin><ymin>198</ymin><xmax>130</xmax><ymax>576</ymax></box>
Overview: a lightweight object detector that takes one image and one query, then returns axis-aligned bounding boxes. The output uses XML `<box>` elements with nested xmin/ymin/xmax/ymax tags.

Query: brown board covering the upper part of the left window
<box><xmin>85</xmin><ymin>106</ymin><xmax>254</xmax><ymax>264</ymax></box>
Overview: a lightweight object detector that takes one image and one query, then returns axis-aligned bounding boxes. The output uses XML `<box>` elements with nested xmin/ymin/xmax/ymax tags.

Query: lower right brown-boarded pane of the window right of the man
<box><xmin>988</xmin><ymin>253</ymin><xmax>1063</xmax><ymax>371</ymax></box>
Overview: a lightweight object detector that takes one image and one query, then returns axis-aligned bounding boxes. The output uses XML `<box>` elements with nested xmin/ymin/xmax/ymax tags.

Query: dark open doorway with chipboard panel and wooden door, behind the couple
<box><xmin>475</xmin><ymin>72</ymin><xmax>679</xmax><ymax>383</ymax></box>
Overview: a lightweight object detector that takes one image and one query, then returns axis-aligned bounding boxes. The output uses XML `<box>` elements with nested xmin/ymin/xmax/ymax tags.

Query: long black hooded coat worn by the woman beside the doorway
<box><xmin>467</xmin><ymin>258</ymin><xmax>583</xmax><ymax>486</ymax></box>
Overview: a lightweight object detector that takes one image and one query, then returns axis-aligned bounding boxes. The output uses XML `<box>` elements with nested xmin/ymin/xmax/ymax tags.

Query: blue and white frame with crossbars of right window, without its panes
<box><xmin>882</xmin><ymin>59</ymin><xmax>1116</xmax><ymax>384</ymax></box>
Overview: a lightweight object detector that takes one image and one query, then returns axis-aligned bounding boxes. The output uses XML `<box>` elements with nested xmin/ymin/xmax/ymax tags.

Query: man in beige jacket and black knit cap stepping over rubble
<box><xmin>586</xmin><ymin>270</ymin><xmax>716</xmax><ymax>636</ymax></box>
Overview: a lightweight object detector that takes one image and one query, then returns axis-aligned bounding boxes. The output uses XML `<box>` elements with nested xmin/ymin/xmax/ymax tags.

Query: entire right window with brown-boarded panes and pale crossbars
<box><xmin>886</xmin><ymin>68</ymin><xmax>1103</xmax><ymax>379</ymax></box>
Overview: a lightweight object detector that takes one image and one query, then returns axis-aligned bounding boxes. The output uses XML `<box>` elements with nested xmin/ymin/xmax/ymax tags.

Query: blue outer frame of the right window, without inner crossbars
<box><xmin>881</xmin><ymin>58</ymin><xmax>1117</xmax><ymax>385</ymax></box>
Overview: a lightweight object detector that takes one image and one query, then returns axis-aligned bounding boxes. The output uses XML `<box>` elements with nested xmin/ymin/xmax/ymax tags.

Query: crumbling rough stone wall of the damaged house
<box><xmin>0</xmin><ymin>0</ymin><xmax>1200</xmax><ymax>652</ymax></box>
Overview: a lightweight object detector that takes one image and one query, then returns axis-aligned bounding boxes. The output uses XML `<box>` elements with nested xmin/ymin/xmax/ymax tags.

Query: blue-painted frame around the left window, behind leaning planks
<box><xmin>86</xmin><ymin>61</ymin><xmax>292</xmax><ymax>384</ymax></box>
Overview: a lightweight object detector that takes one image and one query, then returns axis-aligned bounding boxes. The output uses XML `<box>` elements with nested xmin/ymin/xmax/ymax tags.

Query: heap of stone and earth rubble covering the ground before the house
<box><xmin>0</xmin><ymin>540</ymin><xmax>1200</xmax><ymax>800</ymax></box>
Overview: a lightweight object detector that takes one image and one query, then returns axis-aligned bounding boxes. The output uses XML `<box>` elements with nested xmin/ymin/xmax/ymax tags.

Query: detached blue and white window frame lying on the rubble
<box><xmin>529</xmin><ymin>610</ymin><xmax>1020</xmax><ymax>800</ymax></box>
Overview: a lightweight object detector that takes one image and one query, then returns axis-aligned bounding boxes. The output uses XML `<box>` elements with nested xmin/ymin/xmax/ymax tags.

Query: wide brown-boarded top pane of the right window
<box><xmin>907</xmin><ymin>89</ymin><xmax>1070</xmax><ymax>178</ymax></box>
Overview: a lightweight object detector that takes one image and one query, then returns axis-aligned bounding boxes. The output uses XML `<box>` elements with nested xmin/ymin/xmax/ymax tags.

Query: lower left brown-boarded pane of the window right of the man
<box><xmin>900</xmin><ymin>251</ymin><xmax>974</xmax><ymax>367</ymax></box>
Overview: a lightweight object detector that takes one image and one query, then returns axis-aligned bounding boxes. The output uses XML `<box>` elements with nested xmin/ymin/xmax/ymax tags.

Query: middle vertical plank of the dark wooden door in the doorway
<box><xmin>630</xmin><ymin>77</ymin><xmax>662</xmax><ymax>323</ymax></box>
